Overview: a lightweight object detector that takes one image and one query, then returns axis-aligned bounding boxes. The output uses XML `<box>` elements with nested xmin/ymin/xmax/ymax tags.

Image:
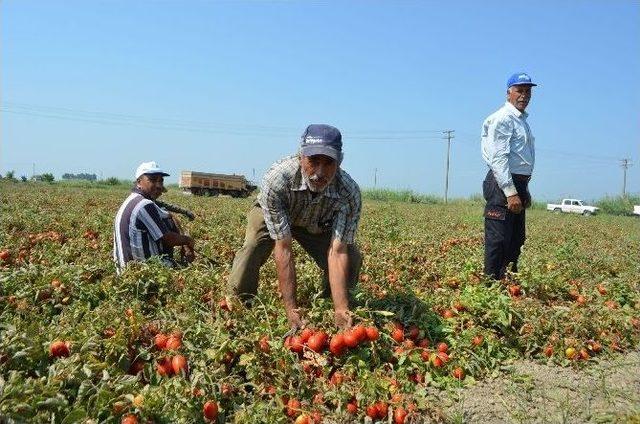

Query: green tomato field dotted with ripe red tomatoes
<box><xmin>0</xmin><ymin>183</ymin><xmax>640</xmax><ymax>423</ymax></box>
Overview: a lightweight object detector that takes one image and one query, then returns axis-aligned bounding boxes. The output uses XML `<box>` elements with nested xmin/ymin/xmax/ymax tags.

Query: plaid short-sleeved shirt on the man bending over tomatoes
<box><xmin>258</xmin><ymin>155</ymin><xmax>362</xmax><ymax>244</ymax></box>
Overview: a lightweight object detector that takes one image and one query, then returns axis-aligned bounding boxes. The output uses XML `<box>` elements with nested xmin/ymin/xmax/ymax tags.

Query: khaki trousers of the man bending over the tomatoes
<box><xmin>228</xmin><ymin>206</ymin><xmax>362</xmax><ymax>300</ymax></box>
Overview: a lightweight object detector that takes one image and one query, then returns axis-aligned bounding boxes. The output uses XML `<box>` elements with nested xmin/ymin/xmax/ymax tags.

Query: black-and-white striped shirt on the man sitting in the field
<box><xmin>113</xmin><ymin>189</ymin><xmax>177</xmax><ymax>272</ymax></box>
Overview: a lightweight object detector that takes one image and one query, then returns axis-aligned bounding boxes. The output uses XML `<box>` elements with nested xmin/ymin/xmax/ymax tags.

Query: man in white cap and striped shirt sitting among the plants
<box><xmin>113</xmin><ymin>162</ymin><xmax>194</xmax><ymax>273</ymax></box>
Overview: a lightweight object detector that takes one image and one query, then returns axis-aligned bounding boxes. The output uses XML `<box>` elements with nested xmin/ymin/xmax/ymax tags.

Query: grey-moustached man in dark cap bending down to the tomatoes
<box><xmin>229</xmin><ymin>124</ymin><xmax>362</xmax><ymax>330</ymax></box>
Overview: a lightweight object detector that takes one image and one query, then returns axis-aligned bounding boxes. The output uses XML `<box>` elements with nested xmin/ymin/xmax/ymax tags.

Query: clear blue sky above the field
<box><xmin>0</xmin><ymin>0</ymin><xmax>640</xmax><ymax>200</ymax></box>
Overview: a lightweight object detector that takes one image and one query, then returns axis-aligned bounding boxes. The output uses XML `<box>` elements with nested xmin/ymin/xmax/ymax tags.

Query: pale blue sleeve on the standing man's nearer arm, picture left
<box><xmin>482</xmin><ymin>119</ymin><xmax>518</xmax><ymax>197</ymax></box>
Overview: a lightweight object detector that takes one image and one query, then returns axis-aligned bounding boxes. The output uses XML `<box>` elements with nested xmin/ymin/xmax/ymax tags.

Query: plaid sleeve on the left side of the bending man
<box><xmin>258</xmin><ymin>172</ymin><xmax>291</xmax><ymax>240</ymax></box>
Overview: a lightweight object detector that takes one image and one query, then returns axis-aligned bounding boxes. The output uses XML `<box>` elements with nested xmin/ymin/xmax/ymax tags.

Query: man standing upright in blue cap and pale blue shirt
<box><xmin>481</xmin><ymin>72</ymin><xmax>536</xmax><ymax>279</ymax></box>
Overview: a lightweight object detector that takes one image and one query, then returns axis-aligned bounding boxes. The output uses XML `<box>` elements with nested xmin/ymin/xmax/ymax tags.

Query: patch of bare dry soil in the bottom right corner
<box><xmin>438</xmin><ymin>350</ymin><xmax>640</xmax><ymax>424</ymax></box>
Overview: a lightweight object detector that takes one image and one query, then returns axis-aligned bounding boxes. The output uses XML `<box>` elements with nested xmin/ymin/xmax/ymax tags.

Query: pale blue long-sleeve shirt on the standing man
<box><xmin>481</xmin><ymin>102</ymin><xmax>536</xmax><ymax>197</ymax></box>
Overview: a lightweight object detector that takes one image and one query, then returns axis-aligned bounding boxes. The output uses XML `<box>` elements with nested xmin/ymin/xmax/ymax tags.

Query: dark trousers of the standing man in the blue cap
<box><xmin>482</xmin><ymin>170</ymin><xmax>531</xmax><ymax>280</ymax></box>
